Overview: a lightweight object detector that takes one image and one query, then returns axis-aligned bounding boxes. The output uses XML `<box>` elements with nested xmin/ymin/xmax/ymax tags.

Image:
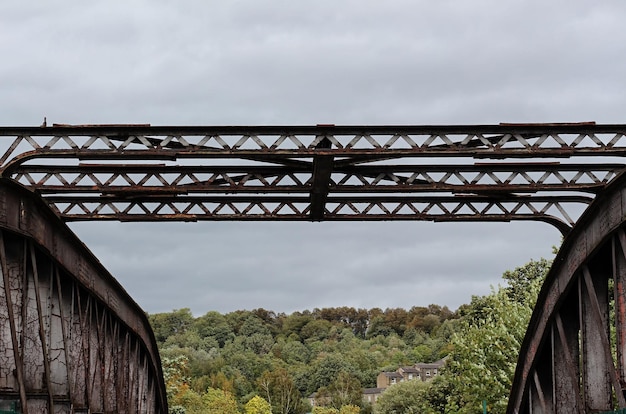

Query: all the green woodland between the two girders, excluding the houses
<box><xmin>148</xmin><ymin>259</ymin><xmax>550</xmax><ymax>414</ymax></box>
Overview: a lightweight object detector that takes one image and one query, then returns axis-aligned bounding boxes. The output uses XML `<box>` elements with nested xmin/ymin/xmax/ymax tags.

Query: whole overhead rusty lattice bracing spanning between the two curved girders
<box><xmin>0</xmin><ymin>123</ymin><xmax>626</xmax><ymax>233</ymax></box>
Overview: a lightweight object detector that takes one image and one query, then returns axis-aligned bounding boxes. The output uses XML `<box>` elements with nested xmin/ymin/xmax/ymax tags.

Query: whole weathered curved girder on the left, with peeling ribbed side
<box><xmin>0</xmin><ymin>180</ymin><xmax>167</xmax><ymax>414</ymax></box>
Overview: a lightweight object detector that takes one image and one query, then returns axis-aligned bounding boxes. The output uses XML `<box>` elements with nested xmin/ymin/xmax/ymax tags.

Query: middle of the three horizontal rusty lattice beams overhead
<box><xmin>12</xmin><ymin>162</ymin><xmax>625</xmax><ymax>195</ymax></box>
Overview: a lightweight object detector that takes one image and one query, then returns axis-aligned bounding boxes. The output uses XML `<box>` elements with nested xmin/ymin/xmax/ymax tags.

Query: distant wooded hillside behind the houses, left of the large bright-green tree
<box><xmin>149</xmin><ymin>305</ymin><xmax>458</xmax><ymax>414</ymax></box>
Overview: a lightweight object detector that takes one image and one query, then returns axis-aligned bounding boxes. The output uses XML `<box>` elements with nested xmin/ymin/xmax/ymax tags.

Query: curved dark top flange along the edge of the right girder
<box><xmin>507</xmin><ymin>173</ymin><xmax>626</xmax><ymax>414</ymax></box>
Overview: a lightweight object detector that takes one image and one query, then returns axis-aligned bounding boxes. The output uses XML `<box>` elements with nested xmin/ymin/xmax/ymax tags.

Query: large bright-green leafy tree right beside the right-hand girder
<box><xmin>445</xmin><ymin>261</ymin><xmax>548</xmax><ymax>413</ymax></box>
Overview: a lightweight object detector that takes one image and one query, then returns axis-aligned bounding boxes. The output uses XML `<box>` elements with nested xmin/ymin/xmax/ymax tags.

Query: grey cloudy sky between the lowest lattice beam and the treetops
<box><xmin>72</xmin><ymin>222</ymin><xmax>560</xmax><ymax>313</ymax></box>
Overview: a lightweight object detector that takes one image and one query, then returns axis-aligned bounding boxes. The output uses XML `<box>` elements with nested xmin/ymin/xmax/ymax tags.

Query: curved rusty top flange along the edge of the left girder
<box><xmin>0</xmin><ymin>178</ymin><xmax>167</xmax><ymax>410</ymax></box>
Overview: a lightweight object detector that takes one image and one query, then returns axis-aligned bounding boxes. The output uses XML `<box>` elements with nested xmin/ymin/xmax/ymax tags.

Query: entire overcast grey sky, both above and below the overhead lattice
<box><xmin>0</xmin><ymin>0</ymin><xmax>626</xmax><ymax>315</ymax></box>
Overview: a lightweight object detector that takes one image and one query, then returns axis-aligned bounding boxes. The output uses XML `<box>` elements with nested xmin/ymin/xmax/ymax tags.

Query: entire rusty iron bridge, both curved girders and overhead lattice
<box><xmin>0</xmin><ymin>122</ymin><xmax>626</xmax><ymax>413</ymax></box>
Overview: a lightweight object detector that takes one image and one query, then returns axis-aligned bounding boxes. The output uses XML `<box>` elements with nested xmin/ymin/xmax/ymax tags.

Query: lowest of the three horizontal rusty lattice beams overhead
<box><xmin>40</xmin><ymin>195</ymin><xmax>592</xmax><ymax>233</ymax></box>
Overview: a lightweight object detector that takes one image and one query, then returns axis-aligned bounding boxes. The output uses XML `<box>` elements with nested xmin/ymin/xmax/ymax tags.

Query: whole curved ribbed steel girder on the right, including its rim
<box><xmin>507</xmin><ymin>174</ymin><xmax>626</xmax><ymax>414</ymax></box>
